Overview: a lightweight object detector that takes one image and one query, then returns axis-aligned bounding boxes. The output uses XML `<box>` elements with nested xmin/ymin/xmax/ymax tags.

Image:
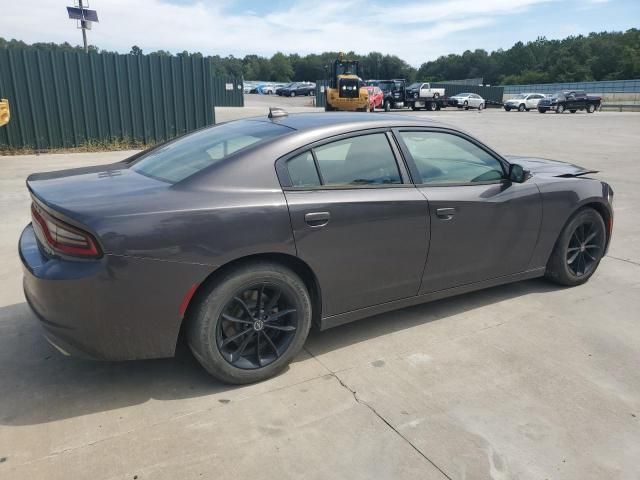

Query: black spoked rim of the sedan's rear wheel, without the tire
<box><xmin>216</xmin><ymin>282</ymin><xmax>298</xmax><ymax>370</ymax></box>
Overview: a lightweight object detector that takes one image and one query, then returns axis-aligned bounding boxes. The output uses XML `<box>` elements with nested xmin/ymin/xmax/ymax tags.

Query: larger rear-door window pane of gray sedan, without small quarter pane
<box><xmin>314</xmin><ymin>133</ymin><xmax>402</xmax><ymax>186</ymax></box>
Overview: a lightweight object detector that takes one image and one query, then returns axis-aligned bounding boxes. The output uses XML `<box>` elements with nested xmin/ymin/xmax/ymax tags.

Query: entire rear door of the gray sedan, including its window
<box><xmin>278</xmin><ymin>131</ymin><xmax>429</xmax><ymax>316</ymax></box>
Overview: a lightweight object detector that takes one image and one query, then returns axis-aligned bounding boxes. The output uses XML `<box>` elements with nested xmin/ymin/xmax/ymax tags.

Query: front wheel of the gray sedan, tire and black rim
<box><xmin>545</xmin><ymin>208</ymin><xmax>607</xmax><ymax>287</ymax></box>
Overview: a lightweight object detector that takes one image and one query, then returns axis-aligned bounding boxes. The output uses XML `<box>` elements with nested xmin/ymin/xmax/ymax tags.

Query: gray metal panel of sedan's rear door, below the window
<box><xmin>286</xmin><ymin>186</ymin><xmax>429</xmax><ymax>315</ymax></box>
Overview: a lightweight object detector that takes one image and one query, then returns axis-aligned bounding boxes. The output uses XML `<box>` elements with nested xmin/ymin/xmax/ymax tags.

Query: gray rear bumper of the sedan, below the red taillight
<box><xmin>19</xmin><ymin>225</ymin><xmax>211</xmax><ymax>360</ymax></box>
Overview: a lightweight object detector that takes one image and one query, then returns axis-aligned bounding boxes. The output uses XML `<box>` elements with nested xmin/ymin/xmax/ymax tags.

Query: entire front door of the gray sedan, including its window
<box><xmin>396</xmin><ymin>130</ymin><xmax>542</xmax><ymax>293</ymax></box>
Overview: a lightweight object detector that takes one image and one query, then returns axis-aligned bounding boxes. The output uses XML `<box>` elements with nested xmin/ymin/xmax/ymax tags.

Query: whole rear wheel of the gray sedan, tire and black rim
<box><xmin>187</xmin><ymin>262</ymin><xmax>312</xmax><ymax>384</ymax></box>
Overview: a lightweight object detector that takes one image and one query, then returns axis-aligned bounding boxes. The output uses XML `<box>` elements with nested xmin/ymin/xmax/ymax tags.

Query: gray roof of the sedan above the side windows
<box><xmin>250</xmin><ymin>112</ymin><xmax>446</xmax><ymax>131</ymax></box>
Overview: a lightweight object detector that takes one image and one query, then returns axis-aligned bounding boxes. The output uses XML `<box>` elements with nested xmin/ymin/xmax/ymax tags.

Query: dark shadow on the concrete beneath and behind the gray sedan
<box><xmin>0</xmin><ymin>280</ymin><xmax>557</xmax><ymax>425</ymax></box>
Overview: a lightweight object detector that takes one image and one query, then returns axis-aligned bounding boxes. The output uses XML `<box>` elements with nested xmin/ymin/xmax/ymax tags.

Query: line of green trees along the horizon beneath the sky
<box><xmin>0</xmin><ymin>28</ymin><xmax>640</xmax><ymax>85</ymax></box>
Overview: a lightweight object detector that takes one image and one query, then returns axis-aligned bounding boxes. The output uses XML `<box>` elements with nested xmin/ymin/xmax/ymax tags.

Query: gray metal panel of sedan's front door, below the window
<box><xmin>420</xmin><ymin>180</ymin><xmax>542</xmax><ymax>294</ymax></box>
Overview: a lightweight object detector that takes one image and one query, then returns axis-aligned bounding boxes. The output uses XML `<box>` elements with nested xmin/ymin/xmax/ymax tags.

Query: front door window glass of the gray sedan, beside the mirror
<box><xmin>400</xmin><ymin>131</ymin><xmax>504</xmax><ymax>184</ymax></box>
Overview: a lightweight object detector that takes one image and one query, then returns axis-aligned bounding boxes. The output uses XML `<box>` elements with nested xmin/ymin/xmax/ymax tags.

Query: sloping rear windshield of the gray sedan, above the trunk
<box><xmin>131</xmin><ymin>120</ymin><xmax>291</xmax><ymax>183</ymax></box>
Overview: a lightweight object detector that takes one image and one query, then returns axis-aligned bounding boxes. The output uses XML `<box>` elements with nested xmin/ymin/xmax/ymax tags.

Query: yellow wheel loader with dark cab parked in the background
<box><xmin>324</xmin><ymin>52</ymin><xmax>369</xmax><ymax>112</ymax></box>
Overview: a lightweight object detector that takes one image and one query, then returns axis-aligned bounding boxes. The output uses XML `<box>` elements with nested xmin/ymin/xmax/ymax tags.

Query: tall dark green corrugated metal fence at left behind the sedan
<box><xmin>0</xmin><ymin>49</ymin><xmax>243</xmax><ymax>150</ymax></box>
